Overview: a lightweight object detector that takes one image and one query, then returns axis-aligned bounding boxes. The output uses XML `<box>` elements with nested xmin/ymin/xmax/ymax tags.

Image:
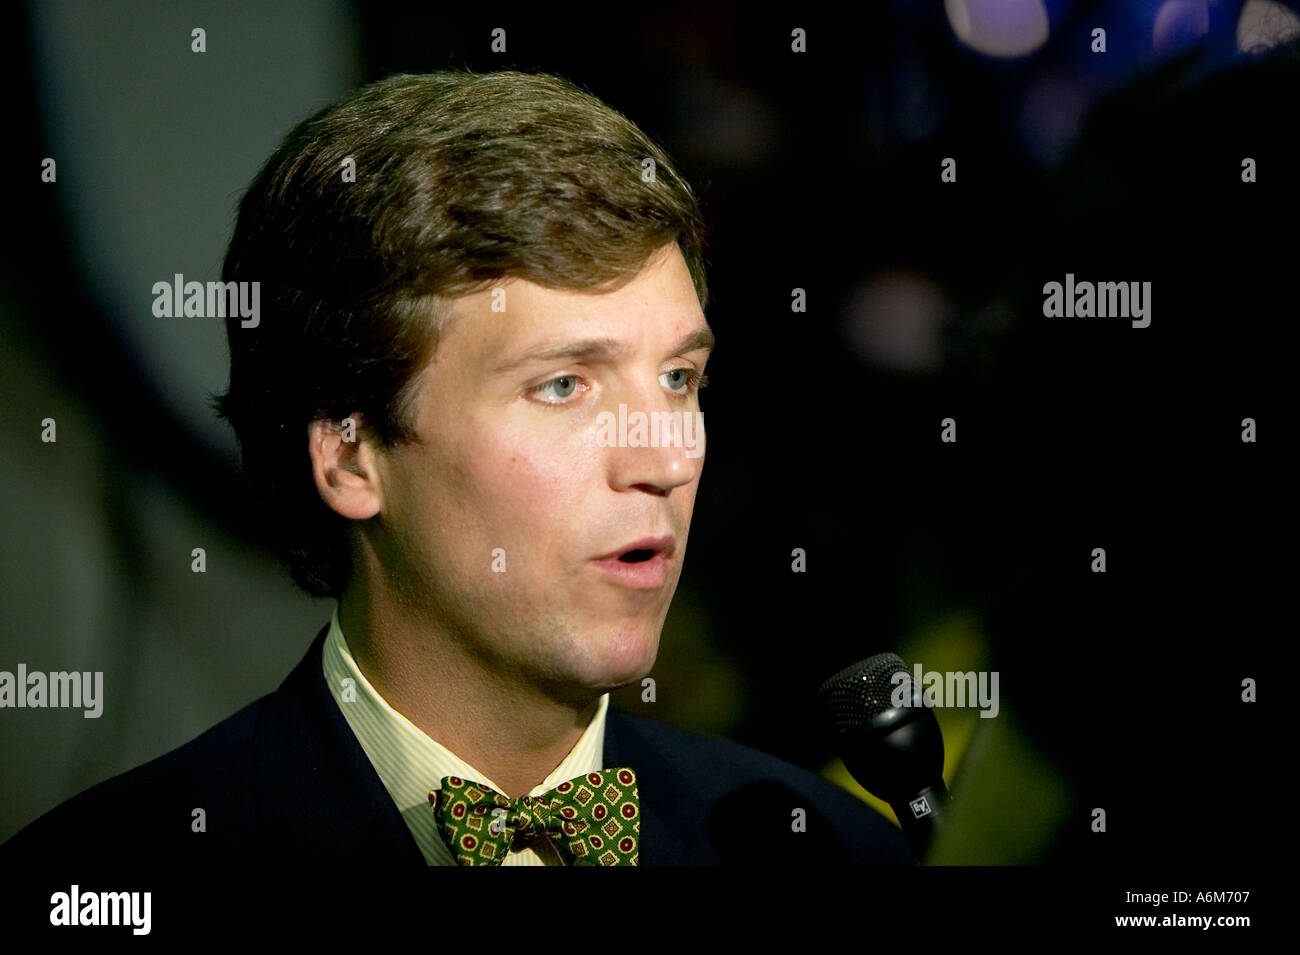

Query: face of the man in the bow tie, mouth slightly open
<box><xmin>366</xmin><ymin>243</ymin><xmax>711</xmax><ymax>699</ymax></box>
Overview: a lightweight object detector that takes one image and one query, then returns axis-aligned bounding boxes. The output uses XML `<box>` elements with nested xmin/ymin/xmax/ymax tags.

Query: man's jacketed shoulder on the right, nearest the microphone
<box><xmin>607</xmin><ymin>709</ymin><xmax>917</xmax><ymax>865</ymax></box>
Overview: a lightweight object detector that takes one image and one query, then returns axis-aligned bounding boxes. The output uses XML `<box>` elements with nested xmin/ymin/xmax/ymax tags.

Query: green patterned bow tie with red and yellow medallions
<box><xmin>429</xmin><ymin>769</ymin><xmax>641</xmax><ymax>865</ymax></box>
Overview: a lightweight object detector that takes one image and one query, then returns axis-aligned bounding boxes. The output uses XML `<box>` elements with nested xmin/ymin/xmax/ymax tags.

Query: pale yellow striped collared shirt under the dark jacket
<box><xmin>321</xmin><ymin>607</ymin><xmax>610</xmax><ymax>865</ymax></box>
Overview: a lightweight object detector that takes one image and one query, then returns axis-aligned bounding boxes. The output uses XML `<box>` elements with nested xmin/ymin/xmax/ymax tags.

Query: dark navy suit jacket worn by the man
<box><xmin>0</xmin><ymin>626</ymin><xmax>915</xmax><ymax>867</ymax></box>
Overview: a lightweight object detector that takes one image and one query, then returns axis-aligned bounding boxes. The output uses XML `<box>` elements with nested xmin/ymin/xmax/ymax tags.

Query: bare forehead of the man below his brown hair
<box><xmin>439</xmin><ymin>244</ymin><xmax>707</xmax><ymax>372</ymax></box>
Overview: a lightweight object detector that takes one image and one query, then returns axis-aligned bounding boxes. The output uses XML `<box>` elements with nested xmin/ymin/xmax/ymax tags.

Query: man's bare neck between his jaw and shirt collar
<box><xmin>338</xmin><ymin>587</ymin><xmax>601</xmax><ymax>799</ymax></box>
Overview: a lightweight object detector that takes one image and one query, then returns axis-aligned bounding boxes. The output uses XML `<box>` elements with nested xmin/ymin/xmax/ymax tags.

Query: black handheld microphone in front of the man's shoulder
<box><xmin>816</xmin><ymin>654</ymin><xmax>949</xmax><ymax>859</ymax></box>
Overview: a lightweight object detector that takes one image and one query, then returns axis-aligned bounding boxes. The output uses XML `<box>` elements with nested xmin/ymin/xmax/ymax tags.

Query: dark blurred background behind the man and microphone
<box><xmin>0</xmin><ymin>0</ymin><xmax>1300</xmax><ymax>867</ymax></box>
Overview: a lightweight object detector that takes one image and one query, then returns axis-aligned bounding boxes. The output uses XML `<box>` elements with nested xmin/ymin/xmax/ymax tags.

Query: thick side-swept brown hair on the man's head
<box><xmin>216</xmin><ymin>71</ymin><xmax>709</xmax><ymax>596</ymax></box>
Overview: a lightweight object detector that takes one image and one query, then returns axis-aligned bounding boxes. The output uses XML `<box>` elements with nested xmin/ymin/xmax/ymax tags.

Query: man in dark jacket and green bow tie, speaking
<box><xmin>4</xmin><ymin>73</ymin><xmax>914</xmax><ymax>865</ymax></box>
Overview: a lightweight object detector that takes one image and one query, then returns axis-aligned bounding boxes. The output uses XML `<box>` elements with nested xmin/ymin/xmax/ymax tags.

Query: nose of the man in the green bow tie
<box><xmin>601</xmin><ymin>382</ymin><xmax>705</xmax><ymax>496</ymax></box>
